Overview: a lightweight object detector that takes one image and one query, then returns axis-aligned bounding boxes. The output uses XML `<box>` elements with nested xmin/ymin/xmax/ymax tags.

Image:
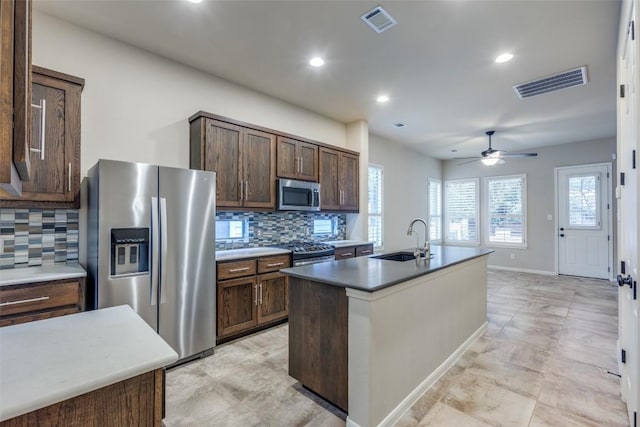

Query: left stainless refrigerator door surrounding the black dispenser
<box><xmin>96</xmin><ymin>160</ymin><xmax>158</xmax><ymax>330</ymax></box>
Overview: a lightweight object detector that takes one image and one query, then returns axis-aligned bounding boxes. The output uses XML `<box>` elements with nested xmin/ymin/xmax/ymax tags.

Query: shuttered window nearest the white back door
<box><xmin>486</xmin><ymin>175</ymin><xmax>527</xmax><ymax>247</ymax></box>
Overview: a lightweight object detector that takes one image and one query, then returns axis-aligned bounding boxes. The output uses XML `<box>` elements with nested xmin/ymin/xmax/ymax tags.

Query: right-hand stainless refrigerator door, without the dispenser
<box><xmin>158</xmin><ymin>167</ymin><xmax>216</xmax><ymax>359</ymax></box>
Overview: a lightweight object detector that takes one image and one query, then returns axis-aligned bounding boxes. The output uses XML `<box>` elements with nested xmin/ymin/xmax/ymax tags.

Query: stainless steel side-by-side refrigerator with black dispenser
<box><xmin>87</xmin><ymin>160</ymin><xmax>216</xmax><ymax>360</ymax></box>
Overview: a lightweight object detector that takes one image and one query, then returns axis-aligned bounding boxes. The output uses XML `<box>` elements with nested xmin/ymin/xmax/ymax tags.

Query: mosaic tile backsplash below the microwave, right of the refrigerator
<box><xmin>216</xmin><ymin>212</ymin><xmax>347</xmax><ymax>250</ymax></box>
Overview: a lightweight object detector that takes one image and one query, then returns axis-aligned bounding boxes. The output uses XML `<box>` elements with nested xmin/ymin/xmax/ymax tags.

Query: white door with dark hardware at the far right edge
<box><xmin>616</xmin><ymin>5</ymin><xmax>640</xmax><ymax>426</ymax></box>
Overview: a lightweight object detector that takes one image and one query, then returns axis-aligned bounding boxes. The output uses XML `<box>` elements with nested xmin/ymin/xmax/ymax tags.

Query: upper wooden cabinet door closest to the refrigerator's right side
<box><xmin>205</xmin><ymin>120</ymin><xmax>242</xmax><ymax>207</ymax></box>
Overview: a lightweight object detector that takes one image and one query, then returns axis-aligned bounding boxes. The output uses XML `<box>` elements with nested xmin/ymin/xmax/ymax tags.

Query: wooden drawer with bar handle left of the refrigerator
<box><xmin>0</xmin><ymin>280</ymin><xmax>83</xmax><ymax>318</ymax></box>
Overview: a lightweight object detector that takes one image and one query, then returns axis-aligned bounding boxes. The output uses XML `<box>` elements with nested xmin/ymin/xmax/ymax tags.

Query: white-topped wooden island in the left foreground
<box><xmin>0</xmin><ymin>306</ymin><xmax>178</xmax><ymax>427</ymax></box>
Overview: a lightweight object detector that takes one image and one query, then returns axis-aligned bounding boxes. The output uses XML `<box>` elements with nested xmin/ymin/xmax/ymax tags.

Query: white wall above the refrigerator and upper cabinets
<box><xmin>33</xmin><ymin>11</ymin><xmax>346</xmax><ymax>177</ymax></box>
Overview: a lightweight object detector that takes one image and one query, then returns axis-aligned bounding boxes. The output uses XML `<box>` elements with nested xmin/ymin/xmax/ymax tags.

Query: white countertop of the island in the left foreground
<box><xmin>0</xmin><ymin>305</ymin><xmax>178</xmax><ymax>421</ymax></box>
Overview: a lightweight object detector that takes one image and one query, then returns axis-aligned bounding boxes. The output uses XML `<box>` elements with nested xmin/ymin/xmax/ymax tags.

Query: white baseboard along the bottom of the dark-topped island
<box><xmin>346</xmin><ymin>322</ymin><xmax>488</xmax><ymax>427</ymax></box>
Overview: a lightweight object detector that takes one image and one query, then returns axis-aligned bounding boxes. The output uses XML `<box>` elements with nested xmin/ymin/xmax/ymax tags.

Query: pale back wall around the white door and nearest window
<box><xmin>442</xmin><ymin>138</ymin><xmax>616</xmax><ymax>273</ymax></box>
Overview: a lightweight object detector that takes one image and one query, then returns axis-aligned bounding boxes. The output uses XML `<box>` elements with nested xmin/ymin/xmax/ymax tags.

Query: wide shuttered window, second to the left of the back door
<box><xmin>444</xmin><ymin>178</ymin><xmax>478</xmax><ymax>244</ymax></box>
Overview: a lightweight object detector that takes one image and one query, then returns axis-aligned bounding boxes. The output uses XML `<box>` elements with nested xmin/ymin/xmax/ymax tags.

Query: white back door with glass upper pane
<box><xmin>556</xmin><ymin>164</ymin><xmax>611</xmax><ymax>279</ymax></box>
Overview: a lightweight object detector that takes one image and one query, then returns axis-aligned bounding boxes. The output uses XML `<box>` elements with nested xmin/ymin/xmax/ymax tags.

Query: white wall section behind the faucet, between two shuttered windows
<box><xmin>369</xmin><ymin>134</ymin><xmax>442</xmax><ymax>250</ymax></box>
